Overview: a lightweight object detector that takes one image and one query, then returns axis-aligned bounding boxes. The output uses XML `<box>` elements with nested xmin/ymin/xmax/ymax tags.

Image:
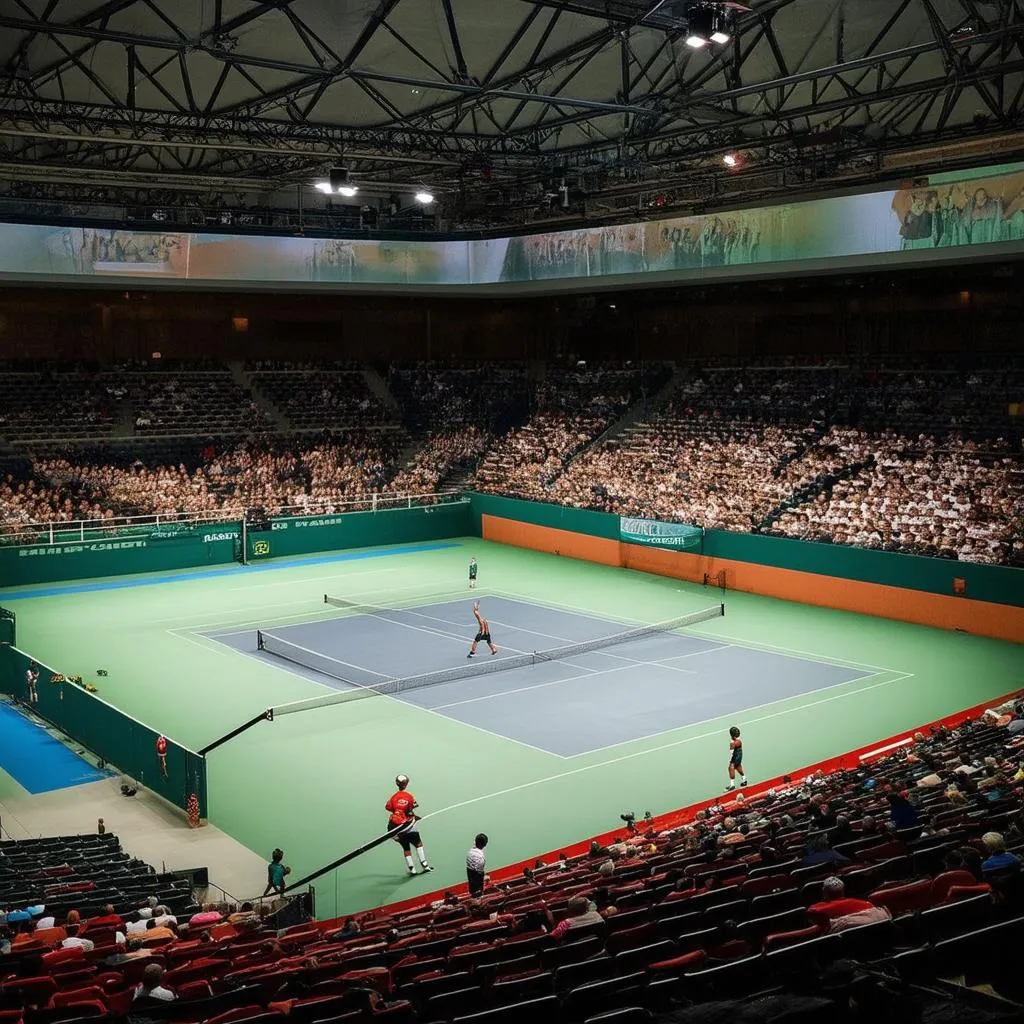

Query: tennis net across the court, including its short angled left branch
<box><xmin>264</xmin><ymin>604</ymin><xmax>725</xmax><ymax>715</ymax></box>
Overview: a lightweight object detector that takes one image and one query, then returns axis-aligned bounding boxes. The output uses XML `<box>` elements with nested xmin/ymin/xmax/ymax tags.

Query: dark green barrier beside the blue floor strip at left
<box><xmin>0</xmin><ymin>645</ymin><xmax>207</xmax><ymax>818</ymax></box>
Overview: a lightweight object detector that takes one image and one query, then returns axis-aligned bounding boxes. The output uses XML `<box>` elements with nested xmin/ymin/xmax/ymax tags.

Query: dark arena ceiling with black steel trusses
<box><xmin>0</xmin><ymin>0</ymin><xmax>1024</xmax><ymax>229</ymax></box>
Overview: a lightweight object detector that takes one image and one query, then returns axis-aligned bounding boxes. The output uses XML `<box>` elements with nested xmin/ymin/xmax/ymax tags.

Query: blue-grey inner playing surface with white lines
<box><xmin>203</xmin><ymin>595</ymin><xmax>872</xmax><ymax>758</ymax></box>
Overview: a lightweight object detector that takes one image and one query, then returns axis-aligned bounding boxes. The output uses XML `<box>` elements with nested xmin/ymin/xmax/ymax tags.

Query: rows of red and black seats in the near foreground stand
<box><xmin>8</xmin><ymin>700</ymin><xmax>1024</xmax><ymax>1024</ymax></box>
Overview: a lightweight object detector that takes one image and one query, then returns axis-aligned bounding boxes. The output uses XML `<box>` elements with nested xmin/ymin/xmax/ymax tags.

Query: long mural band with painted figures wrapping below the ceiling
<box><xmin>0</xmin><ymin>159</ymin><xmax>1024</xmax><ymax>287</ymax></box>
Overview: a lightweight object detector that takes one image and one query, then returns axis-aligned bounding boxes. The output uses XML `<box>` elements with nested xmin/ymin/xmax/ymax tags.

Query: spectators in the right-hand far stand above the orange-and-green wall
<box><xmin>503</xmin><ymin>366</ymin><xmax>1024</xmax><ymax>564</ymax></box>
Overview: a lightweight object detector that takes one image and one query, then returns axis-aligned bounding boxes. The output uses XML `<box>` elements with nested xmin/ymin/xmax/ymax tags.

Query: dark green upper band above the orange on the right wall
<box><xmin>472</xmin><ymin>494</ymin><xmax>1024</xmax><ymax>607</ymax></box>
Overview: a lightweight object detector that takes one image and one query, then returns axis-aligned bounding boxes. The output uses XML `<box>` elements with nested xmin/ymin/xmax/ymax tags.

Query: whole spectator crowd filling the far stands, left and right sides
<box><xmin>0</xmin><ymin>359</ymin><xmax>1024</xmax><ymax>564</ymax></box>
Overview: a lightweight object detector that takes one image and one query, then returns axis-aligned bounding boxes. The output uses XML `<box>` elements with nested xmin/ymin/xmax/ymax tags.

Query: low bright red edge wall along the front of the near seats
<box><xmin>348</xmin><ymin>690</ymin><xmax>1024</xmax><ymax>931</ymax></box>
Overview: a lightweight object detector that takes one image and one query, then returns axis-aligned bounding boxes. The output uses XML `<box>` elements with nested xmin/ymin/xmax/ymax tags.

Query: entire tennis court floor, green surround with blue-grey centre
<box><xmin>0</xmin><ymin>538</ymin><xmax>1024</xmax><ymax>918</ymax></box>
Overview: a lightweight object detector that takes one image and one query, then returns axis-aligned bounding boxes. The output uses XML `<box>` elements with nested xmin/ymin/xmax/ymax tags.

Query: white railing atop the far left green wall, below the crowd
<box><xmin>0</xmin><ymin>490</ymin><xmax>463</xmax><ymax>547</ymax></box>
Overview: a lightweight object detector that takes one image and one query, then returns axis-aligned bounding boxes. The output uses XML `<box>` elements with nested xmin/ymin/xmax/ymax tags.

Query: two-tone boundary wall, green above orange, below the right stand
<box><xmin>472</xmin><ymin>494</ymin><xmax>1024</xmax><ymax>643</ymax></box>
